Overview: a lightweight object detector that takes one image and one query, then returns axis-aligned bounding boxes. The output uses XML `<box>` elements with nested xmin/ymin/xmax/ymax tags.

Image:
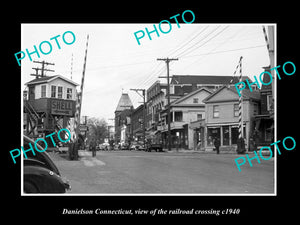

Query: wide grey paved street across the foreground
<box><xmin>51</xmin><ymin>151</ymin><xmax>274</xmax><ymax>194</ymax></box>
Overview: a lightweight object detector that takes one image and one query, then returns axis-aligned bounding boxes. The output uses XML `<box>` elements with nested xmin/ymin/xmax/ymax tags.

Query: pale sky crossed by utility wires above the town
<box><xmin>21</xmin><ymin>22</ymin><xmax>270</xmax><ymax>127</ymax></box>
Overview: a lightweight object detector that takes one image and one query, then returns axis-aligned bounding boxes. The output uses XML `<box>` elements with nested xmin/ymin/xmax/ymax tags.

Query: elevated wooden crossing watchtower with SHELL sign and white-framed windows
<box><xmin>24</xmin><ymin>75</ymin><xmax>78</xmax><ymax>142</ymax></box>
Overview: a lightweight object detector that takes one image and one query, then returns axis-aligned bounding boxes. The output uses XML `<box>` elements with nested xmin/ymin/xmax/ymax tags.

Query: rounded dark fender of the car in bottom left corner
<box><xmin>24</xmin><ymin>165</ymin><xmax>66</xmax><ymax>193</ymax></box>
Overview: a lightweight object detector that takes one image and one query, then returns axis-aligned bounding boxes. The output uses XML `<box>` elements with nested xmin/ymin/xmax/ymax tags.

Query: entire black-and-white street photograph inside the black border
<box><xmin>18</xmin><ymin>23</ymin><xmax>276</xmax><ymax>195</ymax></box>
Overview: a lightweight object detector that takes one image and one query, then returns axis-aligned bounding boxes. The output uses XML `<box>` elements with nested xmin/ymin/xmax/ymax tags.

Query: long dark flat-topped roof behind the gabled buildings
<box><xmin>171</xmin><ymin>75</ymin><xmax>252</xmax><ymax>84</ymax></box>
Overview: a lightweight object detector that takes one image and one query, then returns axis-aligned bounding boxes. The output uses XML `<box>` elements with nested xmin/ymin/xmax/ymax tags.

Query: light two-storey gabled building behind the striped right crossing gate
<box><xmin>203</xmin><ymin>86</ymin><xmax>260</xmax><ymax>151</ymax></box>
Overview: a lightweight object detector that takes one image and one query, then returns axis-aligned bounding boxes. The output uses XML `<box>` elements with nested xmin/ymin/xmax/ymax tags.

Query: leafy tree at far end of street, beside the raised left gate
<box><xmin>87</xmin><ymin>117</ymin><xmax>108</xmax><ymax>143</ymax></box>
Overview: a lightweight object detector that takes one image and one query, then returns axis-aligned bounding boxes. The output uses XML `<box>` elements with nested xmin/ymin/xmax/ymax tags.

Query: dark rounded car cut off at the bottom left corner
<box><xmin>23</xmin><ymin>135</ymin><xmax>71</xmax><ymax>193</ymax></box>
